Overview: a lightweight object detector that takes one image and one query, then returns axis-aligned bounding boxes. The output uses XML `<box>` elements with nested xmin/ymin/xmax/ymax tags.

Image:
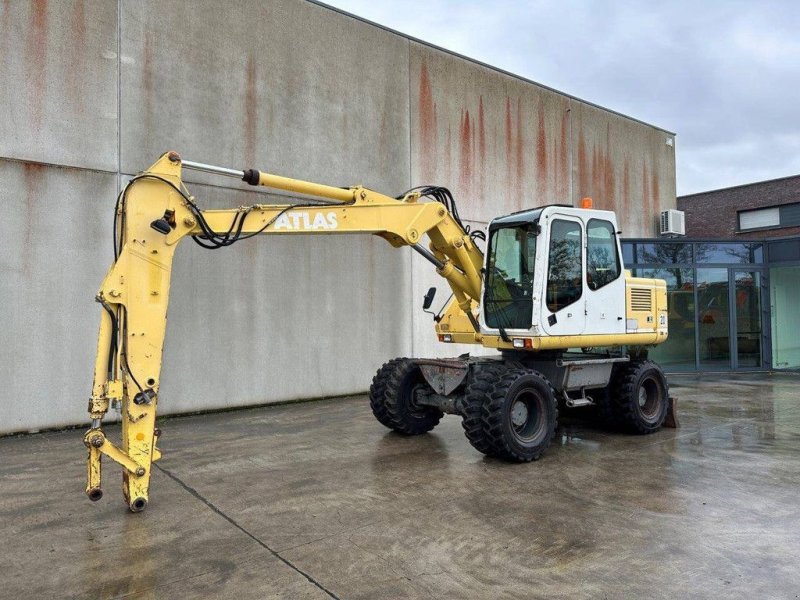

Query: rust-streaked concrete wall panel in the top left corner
<box><xmin>0</xmin><ymin>0</ymin><xmax>117</xmax><ymax>171</ymax></box>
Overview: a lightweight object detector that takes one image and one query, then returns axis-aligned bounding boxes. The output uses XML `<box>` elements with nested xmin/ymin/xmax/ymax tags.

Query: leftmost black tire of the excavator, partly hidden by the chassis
<box><xmin>369</xmin><ymin>358</ymin><xmax>442</xmax><ymax>435</ymax></box>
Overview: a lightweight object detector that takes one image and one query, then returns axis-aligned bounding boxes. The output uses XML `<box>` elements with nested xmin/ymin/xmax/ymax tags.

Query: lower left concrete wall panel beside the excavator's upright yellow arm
<box><xmin>0</xmin><ymin>160</ymin><xmax>117</xmax><ymax>434</ymax></box>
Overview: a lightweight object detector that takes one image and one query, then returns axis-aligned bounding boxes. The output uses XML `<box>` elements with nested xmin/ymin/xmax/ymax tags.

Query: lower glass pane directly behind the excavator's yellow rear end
<box><xmin>635</xmin><ymin>268</ymin><xmax>695</xmax><ymax>372</ymax></box>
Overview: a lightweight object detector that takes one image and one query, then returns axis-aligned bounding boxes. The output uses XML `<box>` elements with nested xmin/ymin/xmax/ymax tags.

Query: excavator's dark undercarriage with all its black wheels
<box><xmin>370</xmin><ymin>351</ymin><xmax>670</xmax><ymax>462</ymax></box>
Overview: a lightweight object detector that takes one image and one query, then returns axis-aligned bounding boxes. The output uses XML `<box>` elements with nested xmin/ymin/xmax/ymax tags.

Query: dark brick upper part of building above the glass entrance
<box><xmin>678</xmin><ymin>175</ymin><xmax>800</xmax><ymax>239</ymax></box>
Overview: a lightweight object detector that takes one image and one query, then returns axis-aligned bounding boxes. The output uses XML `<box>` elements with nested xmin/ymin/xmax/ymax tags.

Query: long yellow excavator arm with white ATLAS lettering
<box><xmin>84</xmin><ymin>152</ymin><xmax>483</xmax><ymax>512</ymax></box>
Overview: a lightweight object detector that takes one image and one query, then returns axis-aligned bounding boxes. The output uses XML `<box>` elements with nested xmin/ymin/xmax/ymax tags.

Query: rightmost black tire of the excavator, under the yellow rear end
<box><xmin>606</xmin><ymin>360</ymin><xmax>669</xmax><ymax>435</ymax></box>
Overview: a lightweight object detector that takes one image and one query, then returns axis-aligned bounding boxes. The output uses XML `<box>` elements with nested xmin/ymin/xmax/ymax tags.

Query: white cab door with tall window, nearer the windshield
<box><xmin>542</xmin><ymin>213</ymin><xmax>586</xmax><ymax>335</ymax></box>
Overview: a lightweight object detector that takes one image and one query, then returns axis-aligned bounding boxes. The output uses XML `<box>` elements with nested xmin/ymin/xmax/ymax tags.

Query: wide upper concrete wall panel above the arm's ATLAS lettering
<box><xmin>122</xmin><ymin>0</ymin><xmax>409</xmax><ymax>194</ymax></box>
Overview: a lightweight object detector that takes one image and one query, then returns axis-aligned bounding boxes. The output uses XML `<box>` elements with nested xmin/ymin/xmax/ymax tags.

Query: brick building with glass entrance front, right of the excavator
<box><xmin>622</xmin><ymin>175</ymin><xmax>800</xmax><ymax>372</ymax></box>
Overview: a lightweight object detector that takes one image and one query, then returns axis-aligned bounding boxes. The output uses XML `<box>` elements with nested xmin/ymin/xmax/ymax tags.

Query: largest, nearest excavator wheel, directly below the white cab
<box><xmin>463</xmin><ymin>365</ymin><xmax>558</xmax><ymax>462</ymax></box>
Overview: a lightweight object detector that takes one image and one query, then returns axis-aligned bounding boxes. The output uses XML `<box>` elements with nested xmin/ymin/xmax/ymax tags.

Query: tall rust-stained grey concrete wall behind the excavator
<box><xmin>0</xmin><ymin>0</ymin><xmax>675</xmax><ymax>433</ymax></box>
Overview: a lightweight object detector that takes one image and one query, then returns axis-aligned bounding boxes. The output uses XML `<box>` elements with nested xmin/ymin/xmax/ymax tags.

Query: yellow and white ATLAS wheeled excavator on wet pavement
<box><xmin>84</xmin><ymin>152</ymin><xmax>669</xmax><ymax>512</ymax></box>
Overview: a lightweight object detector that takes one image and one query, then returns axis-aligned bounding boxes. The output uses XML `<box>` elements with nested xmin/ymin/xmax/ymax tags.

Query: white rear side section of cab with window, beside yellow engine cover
<box><xmin>584</xmin><ymin>218</ymin><xmax>626</xmax><ymax>335</ymax></box>
